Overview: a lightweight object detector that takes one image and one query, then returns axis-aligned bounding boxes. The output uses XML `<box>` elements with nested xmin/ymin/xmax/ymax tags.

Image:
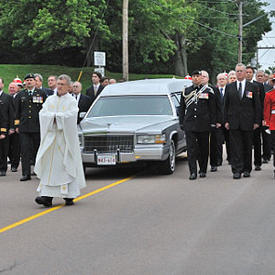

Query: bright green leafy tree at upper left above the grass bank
<box><xmin>0</xmin><ymin>0</ymin><xmax>109</xmax><ymax>64</ymax></box>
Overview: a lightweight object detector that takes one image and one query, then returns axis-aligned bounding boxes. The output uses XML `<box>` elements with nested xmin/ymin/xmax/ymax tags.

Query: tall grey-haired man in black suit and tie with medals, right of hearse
<box><xmin>224</xmin><ymin>63</ymin><xmax>261</xmax><ymax>179</ymax></box>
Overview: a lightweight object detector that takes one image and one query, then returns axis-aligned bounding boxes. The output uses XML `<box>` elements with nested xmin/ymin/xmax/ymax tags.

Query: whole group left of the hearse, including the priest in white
<box><xmin>0</xmin><ymin>72</ymin><xmax>116</xmax><ymax>207</ymax></box>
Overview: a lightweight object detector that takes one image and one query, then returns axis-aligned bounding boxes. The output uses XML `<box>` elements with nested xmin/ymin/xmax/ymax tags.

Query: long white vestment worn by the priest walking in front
<box><xmin>34</xmin><ymin>93</ymin><xmax>86</xmax><ymax>198</ymax></box>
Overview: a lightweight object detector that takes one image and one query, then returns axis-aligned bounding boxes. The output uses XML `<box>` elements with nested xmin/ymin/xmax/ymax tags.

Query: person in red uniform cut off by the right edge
<box><xmin>264</xmin><ymin>74</ymin><xmax>275</xmax><ymax>178</ymax></box>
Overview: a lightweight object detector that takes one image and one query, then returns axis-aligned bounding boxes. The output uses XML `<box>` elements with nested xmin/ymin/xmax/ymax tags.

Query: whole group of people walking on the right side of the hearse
<box><xmin>180</xmin><ymin>63</ymin><xmax>275</xmax><ymax>180</ymax></box>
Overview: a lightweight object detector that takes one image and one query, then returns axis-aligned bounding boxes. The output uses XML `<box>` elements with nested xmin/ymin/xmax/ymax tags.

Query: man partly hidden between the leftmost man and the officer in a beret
<box><xmin>8</xmin><ymin>82</ymin><xmax>20</xmax><ymax>172</ymax></box>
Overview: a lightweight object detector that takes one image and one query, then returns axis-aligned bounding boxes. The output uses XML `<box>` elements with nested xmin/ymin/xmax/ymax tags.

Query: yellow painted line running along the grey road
<box><xmin>0</xmin><ymin>176</ymin><xmax>135</xmax><ymax>234</ymax></box>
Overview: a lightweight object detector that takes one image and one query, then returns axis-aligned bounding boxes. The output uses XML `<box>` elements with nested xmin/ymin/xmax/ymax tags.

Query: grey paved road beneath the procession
<box><xmin>0</xmin><ymin>155</ymin><xmax>275</xmax><ymax>275</ymax></box>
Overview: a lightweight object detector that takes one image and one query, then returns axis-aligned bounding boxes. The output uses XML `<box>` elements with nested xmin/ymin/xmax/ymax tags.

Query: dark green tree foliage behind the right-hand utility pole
<box><xmin>183</xmin><ymin>0</ymin><xmax>271</xmax><ymax>80</ymax></box>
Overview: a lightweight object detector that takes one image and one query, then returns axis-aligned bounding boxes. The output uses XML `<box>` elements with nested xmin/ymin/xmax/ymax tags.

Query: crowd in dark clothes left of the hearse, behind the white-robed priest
<box><xmin>0</xmin><ymin>72</ymin><xmax>116</xmax><ymax>181</ymax></box>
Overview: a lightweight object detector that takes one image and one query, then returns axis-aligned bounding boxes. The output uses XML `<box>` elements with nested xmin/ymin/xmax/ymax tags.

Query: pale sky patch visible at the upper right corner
<box><xmin>255</xmin><ymin>0</ymin><xmax>275</xmax><ymax>70</ymax></box>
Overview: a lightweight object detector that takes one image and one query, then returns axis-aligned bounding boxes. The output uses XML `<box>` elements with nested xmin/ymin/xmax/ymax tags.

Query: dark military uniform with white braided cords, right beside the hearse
<box><xmin>180</xmin><ymin>85</ymin><xmax>216</xmax><ymax>176</ymax></box>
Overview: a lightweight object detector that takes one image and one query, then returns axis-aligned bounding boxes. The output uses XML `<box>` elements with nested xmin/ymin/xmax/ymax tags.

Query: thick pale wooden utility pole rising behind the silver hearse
<box><xmin>122</xmin><ymin>0</ymin><xmax>129</xmax><ymax>81</ymax></box>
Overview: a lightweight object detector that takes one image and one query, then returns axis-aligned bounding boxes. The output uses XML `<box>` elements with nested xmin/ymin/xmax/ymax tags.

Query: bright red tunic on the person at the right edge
<box><xmin>264</xmin><ymin>89</ymin><xmax>275</xmax><ymax>130</ymax></box>
